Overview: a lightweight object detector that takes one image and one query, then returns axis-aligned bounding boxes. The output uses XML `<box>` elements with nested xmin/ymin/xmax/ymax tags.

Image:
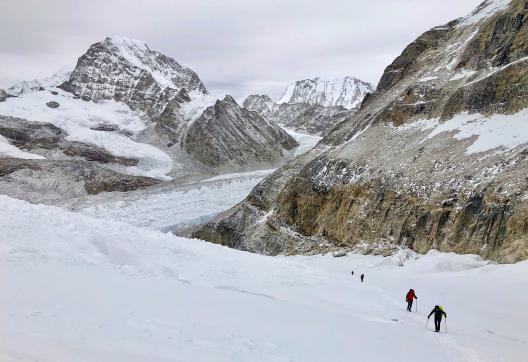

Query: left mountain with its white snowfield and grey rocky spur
<box><xmin>0</xmin><ymin>36</ymin><xmax>297</xmax><ymax>201</ymax></box>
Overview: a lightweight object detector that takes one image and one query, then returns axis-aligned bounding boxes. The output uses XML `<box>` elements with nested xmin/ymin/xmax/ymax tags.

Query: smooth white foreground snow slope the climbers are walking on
<box><xmin>0</xmin><ymin>196</ymin><xmax>528</xmax><ymax>362</ymax></box>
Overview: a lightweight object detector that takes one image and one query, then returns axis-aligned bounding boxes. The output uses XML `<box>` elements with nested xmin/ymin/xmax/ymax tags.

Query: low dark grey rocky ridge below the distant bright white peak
<box><xmin>243</xmin><ymin>95</ymin><xmax>356</xmax><ymax>135</ymax></box>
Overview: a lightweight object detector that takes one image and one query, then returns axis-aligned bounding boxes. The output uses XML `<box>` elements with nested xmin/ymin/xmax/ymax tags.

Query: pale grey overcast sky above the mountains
<box><xmin>0</xmin><ymin>0</ymin><xmax>482</xmax><ymax>97</ymax></box>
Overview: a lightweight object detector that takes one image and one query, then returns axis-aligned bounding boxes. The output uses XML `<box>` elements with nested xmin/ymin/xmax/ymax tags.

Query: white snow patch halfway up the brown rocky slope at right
<box><xmin>423</xmin><ymin>110</ymin><xmax>528</xmax><ymax>154</ymax></box>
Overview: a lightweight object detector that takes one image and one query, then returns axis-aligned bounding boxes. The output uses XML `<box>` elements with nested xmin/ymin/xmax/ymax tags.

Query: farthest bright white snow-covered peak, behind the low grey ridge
<box><xmin>277</xmin><ymin>77</ymin><xmax>374</xmax><ymax>109</ymax></box>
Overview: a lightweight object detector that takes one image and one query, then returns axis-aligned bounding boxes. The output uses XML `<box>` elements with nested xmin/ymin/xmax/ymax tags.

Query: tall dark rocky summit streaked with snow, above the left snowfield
<box><xmin>61</xmin><ymin>36</ymin><xmax>207</xmax><ymax>113</ymax></box>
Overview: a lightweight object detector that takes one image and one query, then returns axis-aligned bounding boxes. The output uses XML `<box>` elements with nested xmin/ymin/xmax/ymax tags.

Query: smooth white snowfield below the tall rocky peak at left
<box><xmin>0</xmin><ymin>88</ymin><xmax>173</xmax><ymax>179</ymax></box>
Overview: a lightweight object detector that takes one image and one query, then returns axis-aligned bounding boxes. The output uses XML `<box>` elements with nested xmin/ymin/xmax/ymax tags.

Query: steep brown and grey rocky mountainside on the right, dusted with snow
<box><xmin>194</xmin><ymin>0</ymin><xmax>528</xmax><ymax>262</ymax></box>
